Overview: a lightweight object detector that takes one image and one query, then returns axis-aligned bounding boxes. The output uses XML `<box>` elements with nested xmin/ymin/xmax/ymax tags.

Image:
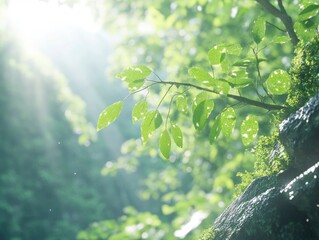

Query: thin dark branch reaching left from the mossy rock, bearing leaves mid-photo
<box><xmin>158</xmin><ymin>81</ymin><xmax>284</xmax><ymax>111</ymax></box>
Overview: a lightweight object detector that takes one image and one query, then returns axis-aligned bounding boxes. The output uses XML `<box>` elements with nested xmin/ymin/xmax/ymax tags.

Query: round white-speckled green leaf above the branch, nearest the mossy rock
<box><xmin>266</xmin><ymin>69</ymin><xmax>290</xmax><ymax>95</ymax></box>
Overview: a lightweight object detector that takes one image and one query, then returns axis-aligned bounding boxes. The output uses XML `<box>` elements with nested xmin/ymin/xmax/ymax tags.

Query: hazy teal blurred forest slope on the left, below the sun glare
<box><xmin>0</xmin><ymin>28</ymin><xmax>142</xmax><ymax>240</ymax></box>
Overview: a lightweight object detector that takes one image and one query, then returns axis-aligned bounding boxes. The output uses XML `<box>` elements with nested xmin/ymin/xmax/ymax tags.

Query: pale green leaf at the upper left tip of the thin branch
<box><xmin>116</xmin><ymin>65</ymin><xmax>152</xmax><ymax>91</ymax></box>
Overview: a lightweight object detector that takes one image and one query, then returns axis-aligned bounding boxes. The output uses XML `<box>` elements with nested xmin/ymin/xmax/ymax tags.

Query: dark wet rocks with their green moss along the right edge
<box><xmin>204</xmin><ymin>35</ymin><xmax>319</xmax><ymax>240</ymax></box>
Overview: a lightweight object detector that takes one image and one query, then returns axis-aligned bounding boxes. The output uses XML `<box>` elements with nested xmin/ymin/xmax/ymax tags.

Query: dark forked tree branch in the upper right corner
<box><xmin>256</xmin><ymin>0</ymin><xmax>299</xmax><ymax>46</ymax></box>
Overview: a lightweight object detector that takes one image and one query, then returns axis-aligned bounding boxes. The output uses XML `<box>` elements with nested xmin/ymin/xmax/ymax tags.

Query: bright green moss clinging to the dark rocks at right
<box><xmin>236</xmin><ymin>34</ymin><xmax>319</xmax><ymax>195</ymax></box>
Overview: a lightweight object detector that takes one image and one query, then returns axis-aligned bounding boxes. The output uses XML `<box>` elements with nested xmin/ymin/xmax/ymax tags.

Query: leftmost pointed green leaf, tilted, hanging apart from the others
<box><xmin>96</xmin><ymin>101</ymin><xmax>123</xmax><ymax>131</ymax></box>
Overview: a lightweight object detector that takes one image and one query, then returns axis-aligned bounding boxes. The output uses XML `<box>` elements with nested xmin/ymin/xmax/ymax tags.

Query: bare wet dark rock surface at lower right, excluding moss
<box><xmin>213</xmin><ymin>95</ymin><xmax>319</xmax><ymax>240</ymax></box>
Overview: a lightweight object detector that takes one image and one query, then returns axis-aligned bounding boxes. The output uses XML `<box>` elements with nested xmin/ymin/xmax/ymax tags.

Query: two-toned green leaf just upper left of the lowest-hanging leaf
<box><xmin>141</xmin><ymin>110</ymin><xmax>163</xmax><ymax>143</ymax></box>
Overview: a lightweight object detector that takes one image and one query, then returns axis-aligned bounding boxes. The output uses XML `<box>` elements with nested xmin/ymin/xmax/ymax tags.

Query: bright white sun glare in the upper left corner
<box><xmin>8</xmin><ymin>0</ymin><xmax>99</xmax><ymax>44</ymax></box>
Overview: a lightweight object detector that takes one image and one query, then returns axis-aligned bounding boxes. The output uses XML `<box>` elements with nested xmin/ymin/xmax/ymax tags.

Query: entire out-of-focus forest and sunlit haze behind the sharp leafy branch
<box><xmin>0</xmin><ymin>0</ymin><xmax>298</xmax><ymax>240</ymax></box>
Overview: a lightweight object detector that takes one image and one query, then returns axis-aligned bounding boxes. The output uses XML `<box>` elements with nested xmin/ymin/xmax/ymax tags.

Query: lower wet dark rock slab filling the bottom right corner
<box><xmin>209</xmin><ymin>163</ymin><xmax>319</xmax><ymax>240</ymax></box>
